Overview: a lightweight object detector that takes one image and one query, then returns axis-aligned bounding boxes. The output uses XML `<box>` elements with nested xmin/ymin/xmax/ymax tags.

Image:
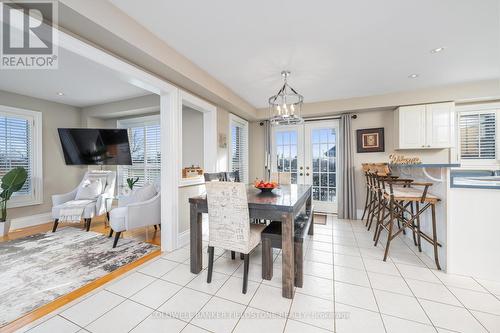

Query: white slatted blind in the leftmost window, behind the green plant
<box><xmin>0</xmin><ymin>113</ymin><xmax>34</xmax><ymax>196</ymax></box>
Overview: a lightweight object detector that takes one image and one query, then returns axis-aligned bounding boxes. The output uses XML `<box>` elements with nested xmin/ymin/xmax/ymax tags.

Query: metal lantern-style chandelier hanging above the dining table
<box><xmin>269</xmin><ymin>71</ymin><xmax>304</xmax><ymax>126</ymax></box>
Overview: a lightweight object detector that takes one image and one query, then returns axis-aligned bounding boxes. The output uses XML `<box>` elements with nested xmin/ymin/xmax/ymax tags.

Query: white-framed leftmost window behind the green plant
<box><xmin>0</xmin><ymin>106</ymin><xmax>43</xmax><ymax>207</ymax></box>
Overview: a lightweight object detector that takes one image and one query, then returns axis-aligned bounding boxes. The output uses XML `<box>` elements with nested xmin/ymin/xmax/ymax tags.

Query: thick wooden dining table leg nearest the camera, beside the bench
<box><xmin>281</xmin><ymin>213</ymin><xmax>295</xmax><ymax>298</ymax></box>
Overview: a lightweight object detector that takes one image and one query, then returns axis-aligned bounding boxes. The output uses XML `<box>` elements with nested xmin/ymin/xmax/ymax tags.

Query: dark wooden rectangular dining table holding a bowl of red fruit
<box><xmin>189</xmin><ymin>185</ymin><xmax>313</xmax><ymax>298</ymax></box>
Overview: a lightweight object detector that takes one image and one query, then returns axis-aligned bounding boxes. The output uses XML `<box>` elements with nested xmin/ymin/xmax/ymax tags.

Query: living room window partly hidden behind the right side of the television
<box><xmin>118</xmin><ymin>116</ymin><xmax>161</xmax><ymax>193</ymax></box>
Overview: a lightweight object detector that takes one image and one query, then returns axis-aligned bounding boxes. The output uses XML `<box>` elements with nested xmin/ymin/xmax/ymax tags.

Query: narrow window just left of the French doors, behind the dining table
<box><xmin>229</xmin><ymin>114</ymin><xmax>248</xmax><ymax>183</ymax></box>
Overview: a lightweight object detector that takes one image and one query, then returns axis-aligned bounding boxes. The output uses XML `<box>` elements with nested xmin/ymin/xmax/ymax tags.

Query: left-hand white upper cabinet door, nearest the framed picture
<box><xmin>398</xmin><ymin>105</ymin><xmax>426</xmax><ymax>149</ymax></box>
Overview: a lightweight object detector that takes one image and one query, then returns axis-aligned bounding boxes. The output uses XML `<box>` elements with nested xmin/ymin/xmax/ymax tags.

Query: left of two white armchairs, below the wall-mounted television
<box><xmin>52</xmin><ymin>170</ymin><xmax>116</xmax><ymax>232</ymax></box>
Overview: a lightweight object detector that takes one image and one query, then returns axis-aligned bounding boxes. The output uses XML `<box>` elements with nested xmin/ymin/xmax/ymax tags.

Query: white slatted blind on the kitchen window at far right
<box><xmin>459</xmin><ymin>112</ymin><xmax>496</xmax><ymax>160</ymax></box>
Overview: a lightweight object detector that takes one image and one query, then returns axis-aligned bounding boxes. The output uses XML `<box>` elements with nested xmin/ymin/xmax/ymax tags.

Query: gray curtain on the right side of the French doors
<box><xmin>337</xmin><ymin>114</ymin><xmax>356</xmax><ymax>219</ymax></box>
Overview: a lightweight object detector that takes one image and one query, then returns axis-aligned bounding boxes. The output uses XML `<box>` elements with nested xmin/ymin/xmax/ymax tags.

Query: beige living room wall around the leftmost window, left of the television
<box><xmin>0</xmin><ymin>91</ymin><xmax>86</xmax><ymax>219</ymax></box>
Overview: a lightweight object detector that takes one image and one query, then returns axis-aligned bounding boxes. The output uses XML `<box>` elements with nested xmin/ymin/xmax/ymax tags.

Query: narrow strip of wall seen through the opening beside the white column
<box><xmin>182</xmin><ymin>106</ymin><xmax>204</xmax><ymax>168</ymax></box>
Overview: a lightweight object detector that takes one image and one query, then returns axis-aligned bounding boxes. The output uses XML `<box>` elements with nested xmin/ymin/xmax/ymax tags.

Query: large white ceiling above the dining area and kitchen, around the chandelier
<box><xmin>110</xmin><ymin>0</ymin><xmax>500</xmax><ymax>107</ymax></box>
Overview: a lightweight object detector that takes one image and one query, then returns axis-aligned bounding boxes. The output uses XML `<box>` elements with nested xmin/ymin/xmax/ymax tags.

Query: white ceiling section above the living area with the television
<box><xmin>0</xmin><ymin>48</ymin><xmax>150</xmax><ymax>107</ymax></box>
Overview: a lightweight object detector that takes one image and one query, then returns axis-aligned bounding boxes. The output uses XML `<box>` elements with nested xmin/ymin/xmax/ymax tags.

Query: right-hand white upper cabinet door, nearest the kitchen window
<box><xmin>426</xmin><ymin>102</ymin><xmax>455</xmax><ymax>148</ymax></box>
